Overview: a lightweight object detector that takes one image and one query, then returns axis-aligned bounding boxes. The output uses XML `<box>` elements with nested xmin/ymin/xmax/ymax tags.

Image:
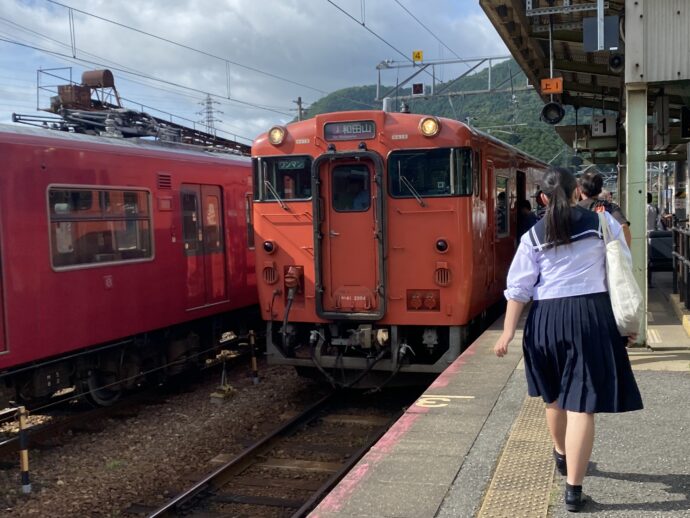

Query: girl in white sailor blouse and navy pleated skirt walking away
<box><xmin>494</xmin><ymin>169</ymin><xmax>642</xmax><ymax>512</ymax></box>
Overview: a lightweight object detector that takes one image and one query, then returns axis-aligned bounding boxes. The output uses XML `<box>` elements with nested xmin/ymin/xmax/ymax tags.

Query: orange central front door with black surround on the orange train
<box><xmin>315</xmin><ymin>154</ymin><xmax>385</xmax><ymax>319</ymax></box>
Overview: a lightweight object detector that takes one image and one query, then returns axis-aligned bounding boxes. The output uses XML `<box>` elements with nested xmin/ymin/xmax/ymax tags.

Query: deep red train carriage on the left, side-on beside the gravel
<box><xmin>0</xmin><ymin>126</ymin><xmax>257</xmax><ymax>404</ymax></box>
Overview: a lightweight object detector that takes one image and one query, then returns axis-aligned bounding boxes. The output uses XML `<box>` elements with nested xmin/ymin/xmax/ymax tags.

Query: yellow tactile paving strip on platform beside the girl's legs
<box><xmin>477</xmin><ymin>397</ymin><xmax>554</xmax><ymax>518</ymax></box>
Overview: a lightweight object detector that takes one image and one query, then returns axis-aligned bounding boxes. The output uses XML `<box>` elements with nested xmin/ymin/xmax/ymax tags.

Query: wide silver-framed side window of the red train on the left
<box><xmin>48</xmin><ymin>187</ymin><xmax>153</xmax><ymax>269</ymax></box>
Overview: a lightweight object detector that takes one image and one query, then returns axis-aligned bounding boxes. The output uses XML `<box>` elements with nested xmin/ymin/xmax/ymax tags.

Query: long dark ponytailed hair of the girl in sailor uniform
<box><xmin>542</xmin><ymin>167</ymin><xmax>577</xmax><ymax>246</ymax></box>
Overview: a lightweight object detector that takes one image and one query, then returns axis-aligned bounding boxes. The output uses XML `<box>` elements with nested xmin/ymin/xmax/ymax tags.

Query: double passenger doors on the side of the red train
<box><xmin>181</xmin><ymin>184</ymin><xmax>227</xmax><ymax>309</ymax></box>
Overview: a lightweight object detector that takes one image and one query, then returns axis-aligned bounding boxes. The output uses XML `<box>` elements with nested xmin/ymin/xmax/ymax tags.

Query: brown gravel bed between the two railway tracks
<box><xmin>0</xmin><ymin>367</ymin><xmax>325</xmax><ymax>517</ymax></box>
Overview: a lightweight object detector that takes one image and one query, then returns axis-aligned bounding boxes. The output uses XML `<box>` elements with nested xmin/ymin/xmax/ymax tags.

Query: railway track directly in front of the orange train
<box><xmin>142</xmin><ymin>390</ymin><xmax>418</xmax><ymax>518</ymax></box>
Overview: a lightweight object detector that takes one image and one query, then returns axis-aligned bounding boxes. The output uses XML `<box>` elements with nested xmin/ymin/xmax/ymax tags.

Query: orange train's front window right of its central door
<box><xmin>388</xmin><ymin>148</ymin><xmax>472</xmax><ymax>198</ymax></box>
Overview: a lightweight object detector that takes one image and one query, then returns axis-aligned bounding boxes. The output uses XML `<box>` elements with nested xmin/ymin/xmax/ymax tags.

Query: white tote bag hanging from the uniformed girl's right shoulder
<box><xmin>599</xmin><ymin>213</ymin><xmax>644</xmax><ymax>336</ymax></box>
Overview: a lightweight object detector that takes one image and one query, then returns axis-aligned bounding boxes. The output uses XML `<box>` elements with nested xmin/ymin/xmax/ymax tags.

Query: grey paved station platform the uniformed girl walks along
<box><xmin>310</xmin><ymin>273</ymin><xmax>690</xmax><ymax>518</ymax></box>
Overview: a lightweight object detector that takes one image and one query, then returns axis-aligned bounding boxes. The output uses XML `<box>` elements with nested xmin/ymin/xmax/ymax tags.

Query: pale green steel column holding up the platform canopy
<box><xmin>625</xmin><ymin>84</ymin><xmax>647</xmax><ymax>344</ymax></box>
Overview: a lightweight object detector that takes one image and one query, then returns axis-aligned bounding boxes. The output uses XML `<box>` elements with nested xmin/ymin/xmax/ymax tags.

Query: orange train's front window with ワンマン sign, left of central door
<box><xmin>253</xmin><ymin>156</ymin><xmax>312</xmax><ymax>201</ymax></box>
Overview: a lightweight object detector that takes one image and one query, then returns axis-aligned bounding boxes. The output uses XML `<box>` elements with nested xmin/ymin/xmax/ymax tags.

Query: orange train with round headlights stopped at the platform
<box><xmin>251</xmin><ymin>111</ymin><xmax>547</xmax><ymax>386</ymax></box>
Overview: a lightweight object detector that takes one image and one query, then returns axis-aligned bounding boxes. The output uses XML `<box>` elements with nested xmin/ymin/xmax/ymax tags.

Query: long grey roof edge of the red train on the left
<box><xmin>0</xmin><ymin>124</ymin><xmax>250</xmax><ymax>163</ymax></box>
